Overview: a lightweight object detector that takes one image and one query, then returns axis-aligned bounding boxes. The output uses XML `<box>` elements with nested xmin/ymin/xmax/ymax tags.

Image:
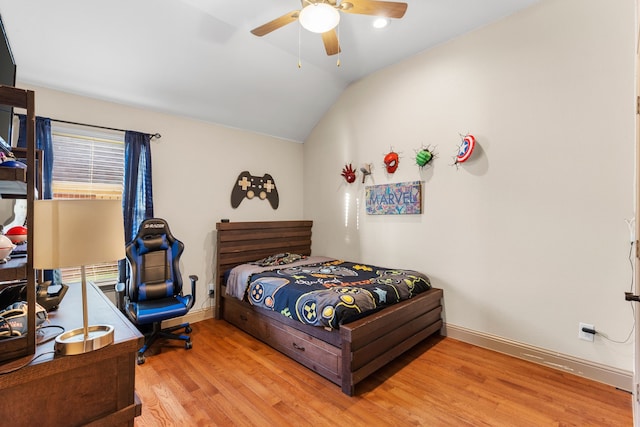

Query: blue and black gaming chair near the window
<box><xmin>118</xmin><ymin>218</ymin><xmax>198</xmax><ymax>365</ymax></box>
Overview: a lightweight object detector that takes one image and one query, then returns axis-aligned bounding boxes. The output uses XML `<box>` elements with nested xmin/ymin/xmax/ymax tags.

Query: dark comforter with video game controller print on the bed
<box><xmin>228</xmin><ymin>257</ymin><xmax>431</xmax><ymax>329</ymax></box>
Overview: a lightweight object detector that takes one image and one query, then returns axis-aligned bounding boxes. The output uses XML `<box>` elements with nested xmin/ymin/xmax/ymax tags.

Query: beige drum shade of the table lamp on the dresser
<box><xmin>33</xmin><ymin>199</ymin><xmax>125</xmax><ymax>269</ymax></box>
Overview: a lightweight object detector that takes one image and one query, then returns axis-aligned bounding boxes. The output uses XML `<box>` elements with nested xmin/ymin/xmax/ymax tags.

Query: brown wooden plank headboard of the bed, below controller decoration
<box><xmin>214</xmin><ymin>221</ymin><xmax>313</xmax><ymax>318</ymax></box>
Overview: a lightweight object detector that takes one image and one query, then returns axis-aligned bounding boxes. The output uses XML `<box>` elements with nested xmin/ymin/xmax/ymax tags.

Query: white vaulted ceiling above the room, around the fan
<box><xmin>0</xmin><ymin>0</ymin><xmax>539</xmax><ymax>142</ymax></box>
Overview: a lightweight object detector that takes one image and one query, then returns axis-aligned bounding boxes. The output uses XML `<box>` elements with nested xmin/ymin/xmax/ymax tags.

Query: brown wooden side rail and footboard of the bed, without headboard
<box><xmin>220</xmin><ymin>288</ymin><xmax>443</xmax><ymax>396</ymax></box>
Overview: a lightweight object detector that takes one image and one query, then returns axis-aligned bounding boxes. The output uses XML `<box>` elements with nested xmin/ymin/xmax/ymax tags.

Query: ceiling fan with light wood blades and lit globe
<box><xmin>251</xmin><ymin>0</ymin><xmax>407</xmax><ymax>55</ymax></box>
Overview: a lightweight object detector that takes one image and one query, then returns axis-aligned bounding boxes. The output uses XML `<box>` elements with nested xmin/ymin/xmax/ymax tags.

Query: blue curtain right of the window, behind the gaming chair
<box><xmin>118</xmin><ymin>131</ymin><xmax>153</xmax><ymax>283</ymax></box>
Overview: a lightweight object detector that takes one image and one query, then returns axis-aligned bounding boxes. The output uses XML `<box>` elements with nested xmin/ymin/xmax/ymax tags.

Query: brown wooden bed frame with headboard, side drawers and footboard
<box><xmin>214</xmin><ymin>221</ymin><xmax>442</xmax><ymax>396</ymax></box>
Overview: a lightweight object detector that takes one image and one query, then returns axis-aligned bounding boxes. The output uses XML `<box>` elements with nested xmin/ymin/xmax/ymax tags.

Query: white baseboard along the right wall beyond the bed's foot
<box><xmin>443</xmin><ymin>324</ymin><xmax>633</xmax><ymax>392</ymax></box>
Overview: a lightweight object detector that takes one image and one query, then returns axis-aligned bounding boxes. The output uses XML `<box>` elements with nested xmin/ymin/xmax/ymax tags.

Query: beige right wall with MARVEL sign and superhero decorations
<box><xmin>304</xmin><ymin>0</ymin><xmax>635</xmax><ymax>371</ymax></box>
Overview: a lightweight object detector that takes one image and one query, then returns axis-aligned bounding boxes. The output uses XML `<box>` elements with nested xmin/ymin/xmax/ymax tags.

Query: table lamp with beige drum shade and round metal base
<box><xmin>32</xmin><ymin>199</ymin><xmax>125</xmax><ymax>355</ymax></box>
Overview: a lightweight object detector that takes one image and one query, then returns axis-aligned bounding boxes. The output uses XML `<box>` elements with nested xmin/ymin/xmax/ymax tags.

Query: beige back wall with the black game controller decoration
<box><xmin>17</xmin><ymin>82</ymin><xmax>302</xmax><ymax>309</ymax></box>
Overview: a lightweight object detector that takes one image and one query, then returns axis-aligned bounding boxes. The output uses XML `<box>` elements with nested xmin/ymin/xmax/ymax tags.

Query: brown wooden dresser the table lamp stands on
<box><xmin>0</xmin><ymin>284</ymin><xmax>144</xmax><ymax>427</ymax></box>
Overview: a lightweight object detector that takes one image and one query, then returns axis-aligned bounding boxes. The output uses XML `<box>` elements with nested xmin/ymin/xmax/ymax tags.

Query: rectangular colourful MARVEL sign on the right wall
<box><xmin>365</xmin><ymin>181</ymin><xmax>422</xmax><ymax>215</ymax></box>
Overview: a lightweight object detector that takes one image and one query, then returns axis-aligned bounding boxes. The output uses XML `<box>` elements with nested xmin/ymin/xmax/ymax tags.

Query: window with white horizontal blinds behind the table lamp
<box><xmin>51</xmin><ymin>123</ymin><xmax>124</xmax><ymax>284</ymax></box>
